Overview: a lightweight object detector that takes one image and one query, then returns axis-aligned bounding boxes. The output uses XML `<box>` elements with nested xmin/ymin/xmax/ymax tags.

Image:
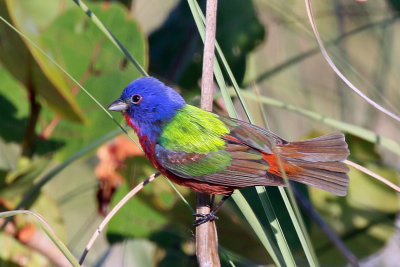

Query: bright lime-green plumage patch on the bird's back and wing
<box><xmin>157</xmin><ymin>105</ymin><xmax>232</xmax><ymax>176</ymax></box>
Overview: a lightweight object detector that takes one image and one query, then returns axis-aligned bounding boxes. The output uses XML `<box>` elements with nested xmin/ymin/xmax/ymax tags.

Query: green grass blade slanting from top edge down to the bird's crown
<box><xmin>72</xmin><ymin>0</ymin><xmax>149</xmax><ymax>76</ymax></box>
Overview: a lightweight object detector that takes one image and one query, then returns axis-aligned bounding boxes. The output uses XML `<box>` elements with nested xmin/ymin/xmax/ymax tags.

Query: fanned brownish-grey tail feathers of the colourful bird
<box><xmin>277</xmin><ymin>132</ymin><xmax>349</xmax><ymax>196</ymax></box>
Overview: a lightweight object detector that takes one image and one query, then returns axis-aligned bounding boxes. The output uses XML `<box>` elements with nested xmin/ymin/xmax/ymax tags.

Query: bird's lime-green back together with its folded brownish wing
<box><xmin>155</xmin><ymin>110</ymin><xmax>286</xmax><ymax>188</ymax></box>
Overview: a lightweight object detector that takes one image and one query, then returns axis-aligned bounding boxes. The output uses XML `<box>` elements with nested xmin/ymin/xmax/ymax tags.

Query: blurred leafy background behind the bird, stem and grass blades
<box><xmin>0</xmin><ymin>0</ymin><xmax>400</xmax><ymax>266</ymax></box>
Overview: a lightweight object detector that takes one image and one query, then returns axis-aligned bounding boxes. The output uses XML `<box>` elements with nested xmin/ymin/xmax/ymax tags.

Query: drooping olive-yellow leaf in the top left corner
<box><xmin>0</xmin><ymin>0</ymin><xmax>84</xmax><ymax>121</ymax></box>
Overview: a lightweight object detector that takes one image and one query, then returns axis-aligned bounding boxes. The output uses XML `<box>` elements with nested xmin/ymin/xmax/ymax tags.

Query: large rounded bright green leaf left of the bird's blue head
<box><xmin>36</xmin><ymin>4</ymin><xmax>147</xmax><ymax>158</ymax></box>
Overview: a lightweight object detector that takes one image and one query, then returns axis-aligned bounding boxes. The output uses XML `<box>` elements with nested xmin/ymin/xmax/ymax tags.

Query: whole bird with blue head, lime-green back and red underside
<box><xmin>108</xmin><ymin>77</ymin><xmax>349</xmax><ymax>226</ymax></box>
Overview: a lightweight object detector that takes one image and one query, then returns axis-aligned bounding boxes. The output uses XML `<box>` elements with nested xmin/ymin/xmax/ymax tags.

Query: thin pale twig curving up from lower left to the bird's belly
<box><xmin>79</xmin><ymin>172</ymin><xmax>160</xmax><ymax>265</ymax></box>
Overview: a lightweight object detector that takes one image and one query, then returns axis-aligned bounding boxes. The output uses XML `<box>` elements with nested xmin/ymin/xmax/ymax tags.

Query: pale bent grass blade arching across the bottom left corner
<box><xmin>0</xmin><ymin>210</ymin><xmax>80</xmax><ymax>267</ymax></box>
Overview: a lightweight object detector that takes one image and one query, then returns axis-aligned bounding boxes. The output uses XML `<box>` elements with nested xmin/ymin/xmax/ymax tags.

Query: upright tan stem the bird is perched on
<box><xmin>196</xmin><ymin>0</ymin><xmax>221</xmax><ymax>267</ymax></box>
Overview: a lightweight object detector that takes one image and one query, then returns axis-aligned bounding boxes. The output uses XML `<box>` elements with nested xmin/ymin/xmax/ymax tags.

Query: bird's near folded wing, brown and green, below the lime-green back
<box><xmin>155</xmin><ymin>144</ymin><xmax>284</xmax><ymax>188</ymax></box>
